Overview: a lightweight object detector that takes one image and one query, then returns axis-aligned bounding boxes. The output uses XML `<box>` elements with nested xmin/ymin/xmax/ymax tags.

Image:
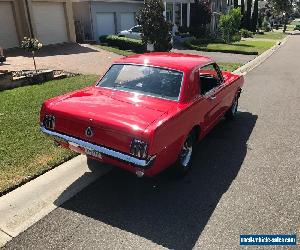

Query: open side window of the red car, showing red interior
<box><xmin>199</xmin><ymin>64</ymin><xmax>222</xmax><ymax>95</ymax></box>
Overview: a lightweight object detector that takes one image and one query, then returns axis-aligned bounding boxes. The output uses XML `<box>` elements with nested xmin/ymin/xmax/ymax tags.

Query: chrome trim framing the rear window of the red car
<box><xmin>96</xmin><ymin>63</ymin><xmax>185</xmax><ymax>102</ymax></box>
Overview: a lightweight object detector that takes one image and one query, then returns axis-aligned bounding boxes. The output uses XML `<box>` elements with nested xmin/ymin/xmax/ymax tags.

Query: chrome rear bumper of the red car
<box><xmin>40</xmin><ymin>126</ymin><xmax>156</xmax><ymax>168</ymax></box>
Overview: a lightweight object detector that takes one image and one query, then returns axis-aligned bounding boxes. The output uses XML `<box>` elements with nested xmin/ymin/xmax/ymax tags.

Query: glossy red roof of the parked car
<box><xmin>115</xmin><ymin>52</ymin><xmax>214</xmax><ymax>71</ymax></box>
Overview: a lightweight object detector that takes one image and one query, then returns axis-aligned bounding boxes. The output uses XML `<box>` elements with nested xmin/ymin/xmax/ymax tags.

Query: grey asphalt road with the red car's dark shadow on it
<box><xmin>5</xmin><ymin>35</ymin><xmax>300</xmax><ymax>250</ymax></box>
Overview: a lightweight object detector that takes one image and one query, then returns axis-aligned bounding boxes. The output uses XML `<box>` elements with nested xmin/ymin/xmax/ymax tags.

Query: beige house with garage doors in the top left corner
<box><xmin>0</xmin><ymin>0</ymin><xmax>76</xmax><ymax>49</ymax></box>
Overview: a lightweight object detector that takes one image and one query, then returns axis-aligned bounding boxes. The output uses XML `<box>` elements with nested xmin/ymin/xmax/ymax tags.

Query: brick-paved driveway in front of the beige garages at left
<box><xmin>0</xmin><ymin>43</ymin><xmax>121</xmax><ymax>75</ymax></box>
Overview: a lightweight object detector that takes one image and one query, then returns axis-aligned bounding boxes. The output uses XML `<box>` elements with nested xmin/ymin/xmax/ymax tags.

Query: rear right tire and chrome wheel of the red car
<box><xmin>175</xmin><ymin>131</ymin><xmax>196</xmax><ymax>177</ymax></box>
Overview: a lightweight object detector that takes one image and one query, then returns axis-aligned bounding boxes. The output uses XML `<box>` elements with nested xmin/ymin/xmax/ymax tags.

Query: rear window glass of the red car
<box><xmin>97</xmin><ymin>64</ymin><xmax>183</xmax><ymax>100</ymax></box>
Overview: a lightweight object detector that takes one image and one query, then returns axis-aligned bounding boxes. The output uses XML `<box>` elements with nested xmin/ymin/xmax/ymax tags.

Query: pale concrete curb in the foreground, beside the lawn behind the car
<box><xmin>0</xmin><ymin>155</ymin><xmax>111</xmax><ymax>247</ymax></box>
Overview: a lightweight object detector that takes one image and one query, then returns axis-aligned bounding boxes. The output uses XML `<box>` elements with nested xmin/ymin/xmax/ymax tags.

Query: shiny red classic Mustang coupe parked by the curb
<box><xmin>40</xmin><ymin>53</ymin><xmax>244</xmax><ymax>176</ymax></box>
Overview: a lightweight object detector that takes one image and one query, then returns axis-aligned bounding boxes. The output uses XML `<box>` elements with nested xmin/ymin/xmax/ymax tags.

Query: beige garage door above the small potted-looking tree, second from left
<box><xmin>33</xmin><ymin>2</ymin><xmax>68</xmax><ymax>44</ymax></box>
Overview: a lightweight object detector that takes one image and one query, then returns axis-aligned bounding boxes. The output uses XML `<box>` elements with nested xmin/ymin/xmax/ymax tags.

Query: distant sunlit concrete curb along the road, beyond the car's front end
<box><xmin>233</xmin><ymin>35</ymin><xmax>291</xmax><ymax>75</ymax></box>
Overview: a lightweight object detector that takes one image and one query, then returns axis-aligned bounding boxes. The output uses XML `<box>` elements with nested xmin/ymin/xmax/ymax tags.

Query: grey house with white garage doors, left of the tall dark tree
<box><xmin>73</xmin><ymin>0</ymin><xmax>144</xmax><ymax>42</ymax></box>
